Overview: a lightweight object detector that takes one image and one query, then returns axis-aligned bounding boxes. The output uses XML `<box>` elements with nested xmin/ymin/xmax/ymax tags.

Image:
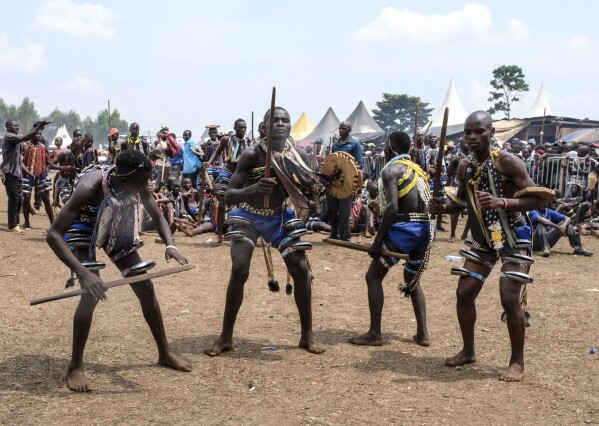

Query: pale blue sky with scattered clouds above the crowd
<box><xmin>0</xmin><ymin>0</ymin><xmax>599</xmax><ymax>134</ymax></box>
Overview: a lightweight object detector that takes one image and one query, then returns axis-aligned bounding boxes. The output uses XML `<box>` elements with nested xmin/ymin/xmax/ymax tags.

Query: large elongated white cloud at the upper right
<box><xmin>354</xmin><ymin>4</ymin><xmax>493</xmax><ymax>43</ymax></box>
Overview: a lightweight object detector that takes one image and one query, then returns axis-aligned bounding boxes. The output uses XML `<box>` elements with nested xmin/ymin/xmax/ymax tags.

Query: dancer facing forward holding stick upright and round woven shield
<box><xmin>205</xmin><ymin>107</ymin><xmax>325</xmax><ymax>356</ymax></box>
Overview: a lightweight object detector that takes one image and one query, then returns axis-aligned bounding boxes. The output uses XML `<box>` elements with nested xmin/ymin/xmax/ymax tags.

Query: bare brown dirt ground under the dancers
<box><xmin>0</xmin><ymin>188</ymin><xmax>599</xmax><ymax>425</ymax></box>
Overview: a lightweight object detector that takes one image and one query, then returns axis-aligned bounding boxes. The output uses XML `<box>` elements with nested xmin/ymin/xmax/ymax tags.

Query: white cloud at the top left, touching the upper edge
<box><xmin>35</xmin><ymin>0</ymin><xmax>119</xmax><ymax>37</ymax></box>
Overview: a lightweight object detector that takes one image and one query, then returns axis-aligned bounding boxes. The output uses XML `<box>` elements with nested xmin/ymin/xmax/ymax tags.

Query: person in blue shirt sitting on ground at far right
<box><xmin>528</xmin><ymin>208</ymin><xmax>593</xmax><ymax>257</ymax></box>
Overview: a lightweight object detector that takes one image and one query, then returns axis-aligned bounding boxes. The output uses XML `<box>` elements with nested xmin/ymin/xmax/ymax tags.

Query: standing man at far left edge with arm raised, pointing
<box><xmin>0</xmin><ymin>120</ymin><xmax>51</xmax><ymax>234</ymax></box>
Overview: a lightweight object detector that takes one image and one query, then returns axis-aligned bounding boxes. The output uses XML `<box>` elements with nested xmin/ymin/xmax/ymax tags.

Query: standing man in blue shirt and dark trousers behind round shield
<box><xmin>327</xmin><ymin>121</ymin><xmax>364</xmax><ymax>241</ymax></box>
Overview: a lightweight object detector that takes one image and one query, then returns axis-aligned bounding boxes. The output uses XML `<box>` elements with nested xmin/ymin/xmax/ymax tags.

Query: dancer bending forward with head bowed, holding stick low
<box><xmin>46</xmin><ymin>149</ymin><xmax>191</xmax><ymax>392</ymax></box>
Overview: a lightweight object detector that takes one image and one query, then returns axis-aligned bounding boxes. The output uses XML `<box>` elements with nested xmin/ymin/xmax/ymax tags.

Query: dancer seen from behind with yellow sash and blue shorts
<box><xmin>349</xmin><ymin>132</ymin><xmax>435</xmax><ymax>346</ymax></box>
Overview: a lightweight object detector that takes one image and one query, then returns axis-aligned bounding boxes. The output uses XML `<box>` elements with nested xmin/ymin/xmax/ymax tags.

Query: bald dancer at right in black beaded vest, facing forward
<box><xmin>429</xmin><ymin>111</ymin><xmax>544</xmax><ymax>382</ymax></box>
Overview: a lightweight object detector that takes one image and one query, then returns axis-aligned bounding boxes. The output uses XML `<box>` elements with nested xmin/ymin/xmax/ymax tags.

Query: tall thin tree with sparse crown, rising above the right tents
<box><xmin>487</xmin><ymin>65</ymin><xmax>528</xmax><ymax>119</ymax></box>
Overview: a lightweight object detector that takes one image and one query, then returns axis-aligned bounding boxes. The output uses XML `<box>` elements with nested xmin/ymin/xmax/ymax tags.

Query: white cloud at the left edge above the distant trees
<box><xmin>0</xmin><ymin>34</ymin><xmax>46</xmax><ymax>74</ymax></box>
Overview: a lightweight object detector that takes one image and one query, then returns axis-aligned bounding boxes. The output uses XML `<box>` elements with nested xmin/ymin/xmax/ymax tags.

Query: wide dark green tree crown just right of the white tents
<box><xmin>372</xmin><ymin>93</ymin><xmax>433</xmax><ymax>132</ymax></box>
